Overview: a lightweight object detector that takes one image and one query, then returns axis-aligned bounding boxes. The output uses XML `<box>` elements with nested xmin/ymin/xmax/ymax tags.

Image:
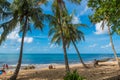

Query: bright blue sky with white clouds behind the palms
<box><xmin>0</xmin><ymin>0</ymin><xmax>120</xmax><ymax>53</ymax></box>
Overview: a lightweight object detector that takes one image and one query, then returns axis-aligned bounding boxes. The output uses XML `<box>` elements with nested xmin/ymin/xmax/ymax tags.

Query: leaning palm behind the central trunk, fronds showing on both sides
<box><xmin>49</xmin><ymin>11</ymin><xmax>87</xmax><ymax>68</ymax></box>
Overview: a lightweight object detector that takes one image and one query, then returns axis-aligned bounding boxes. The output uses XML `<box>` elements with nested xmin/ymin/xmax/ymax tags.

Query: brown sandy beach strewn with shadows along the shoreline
<box><xmin>1</xmin><ymin>61</ymin><xmax>120</xmax><ymax>80</ymax></box>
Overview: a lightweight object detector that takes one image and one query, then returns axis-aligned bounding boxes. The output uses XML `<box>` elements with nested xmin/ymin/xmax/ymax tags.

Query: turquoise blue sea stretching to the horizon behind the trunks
<box><xmin>0</xmin><ymin>54</ymin><xmax>117</xmax><ymax>65</ymax></box>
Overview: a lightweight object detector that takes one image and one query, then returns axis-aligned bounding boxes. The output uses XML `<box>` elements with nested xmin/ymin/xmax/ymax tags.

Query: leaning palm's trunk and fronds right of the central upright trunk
<box><xmin>64</xmin><ymin>16</ymin><xmax>88</xmax><ymax>68</ymax></box>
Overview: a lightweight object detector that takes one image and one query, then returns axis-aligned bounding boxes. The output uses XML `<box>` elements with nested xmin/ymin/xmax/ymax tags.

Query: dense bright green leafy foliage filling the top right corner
<box><xmin>88</xmin><ymin>0</ymin><xmax>120</xmax><ymax>34</ymax></box>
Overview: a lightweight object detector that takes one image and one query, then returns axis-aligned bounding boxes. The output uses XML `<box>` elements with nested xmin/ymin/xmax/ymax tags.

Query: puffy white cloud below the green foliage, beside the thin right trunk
<box><xmin>94</xmin><ymin>21</ymin><xmax>108</xmax><ymax>35</ymax></box>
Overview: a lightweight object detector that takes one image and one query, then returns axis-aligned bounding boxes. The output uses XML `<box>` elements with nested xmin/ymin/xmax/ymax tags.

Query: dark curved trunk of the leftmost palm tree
<box><xmin>9</xmin><ymin>18</ymin><xmax>27</xmax><ymax>80</ymax></box>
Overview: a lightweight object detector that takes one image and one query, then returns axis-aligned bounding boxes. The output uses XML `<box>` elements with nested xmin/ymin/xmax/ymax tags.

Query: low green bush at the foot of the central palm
<box><xmin>64</xmin><ymin>70</ymin><xmax>85</xmax><ymax>80</ymax></box>
